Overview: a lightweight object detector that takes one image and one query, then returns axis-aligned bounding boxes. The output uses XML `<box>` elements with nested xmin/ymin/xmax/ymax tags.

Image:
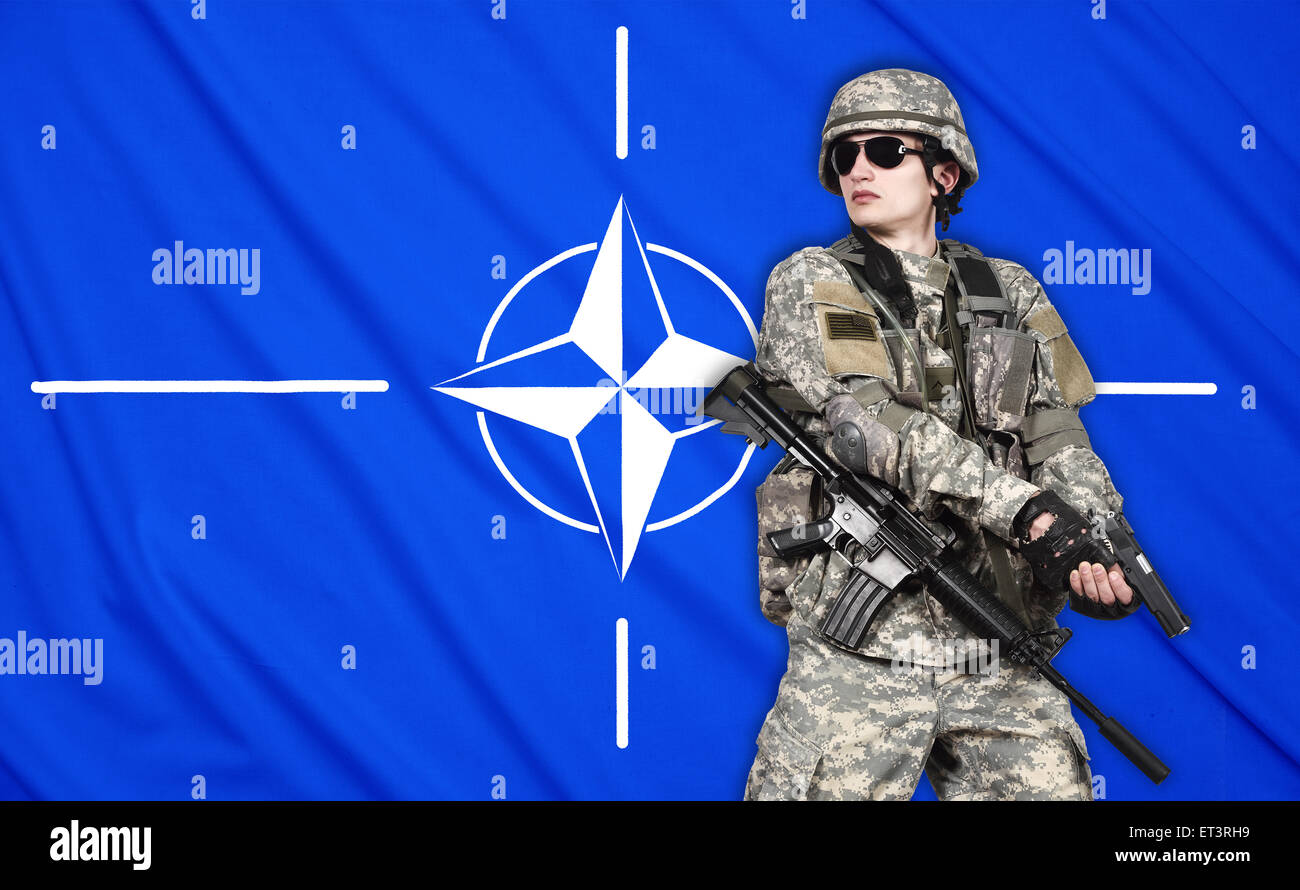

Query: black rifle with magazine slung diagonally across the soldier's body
<box><xmin>703</xmin><ymin>365</ymin><xmax>1169</xmax><ymax>785</ymax></box>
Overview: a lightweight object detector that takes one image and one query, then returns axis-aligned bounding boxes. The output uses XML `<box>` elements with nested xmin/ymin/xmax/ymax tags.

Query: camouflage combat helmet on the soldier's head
<box><xmin>818</xmin><ymin>68</ymin><xmax>979</xmax><ymax>195</ymax></box>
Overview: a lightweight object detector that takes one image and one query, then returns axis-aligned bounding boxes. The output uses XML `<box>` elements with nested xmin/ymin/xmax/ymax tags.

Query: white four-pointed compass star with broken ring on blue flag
<box><xmin>432</xmin><ymin>197</ymin><xmax>758</xmax><ymax>578</ymax></box>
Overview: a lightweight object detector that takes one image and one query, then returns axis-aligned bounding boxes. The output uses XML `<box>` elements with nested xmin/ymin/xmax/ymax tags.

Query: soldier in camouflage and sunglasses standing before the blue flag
<box><xmin>745</xmin><ymin>69</ymin><xmax>1139</xmax><ymax>800</ymax></box>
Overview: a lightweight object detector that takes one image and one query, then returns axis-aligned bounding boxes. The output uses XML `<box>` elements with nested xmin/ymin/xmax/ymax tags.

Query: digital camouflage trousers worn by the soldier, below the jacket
<box><xmin>745</xmin><ymin>616</ymin><xmax>1092</xmax><ymax>800</ymax></box>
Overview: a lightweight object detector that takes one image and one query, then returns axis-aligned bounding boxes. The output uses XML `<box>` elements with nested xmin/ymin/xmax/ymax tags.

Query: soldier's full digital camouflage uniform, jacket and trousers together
<box><xmin>746</xmin><ymin>71</ymin><xmax>1122</xmax><ymax>799</ymax></box>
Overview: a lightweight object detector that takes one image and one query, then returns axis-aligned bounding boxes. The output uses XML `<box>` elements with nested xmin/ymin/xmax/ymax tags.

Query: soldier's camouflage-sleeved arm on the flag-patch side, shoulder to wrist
<box><xmin>755</xmin><ymin>251</ymin><xmax>1040</xmax><ymax>539</ymax></box>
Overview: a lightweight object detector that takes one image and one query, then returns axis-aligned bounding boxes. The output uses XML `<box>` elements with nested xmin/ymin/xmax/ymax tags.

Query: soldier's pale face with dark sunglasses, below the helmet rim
<box><xmin>840</xmin><ymin>130</ymin><xmax>937</xmax><ymax>234</ymax></box>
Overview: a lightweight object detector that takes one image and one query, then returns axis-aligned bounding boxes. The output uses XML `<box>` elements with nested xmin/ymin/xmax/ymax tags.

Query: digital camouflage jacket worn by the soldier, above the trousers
<box><xmin>755</xmin><ymin>240</ymin><xmax>1122</xmax><ymax>665</ymax></box>
